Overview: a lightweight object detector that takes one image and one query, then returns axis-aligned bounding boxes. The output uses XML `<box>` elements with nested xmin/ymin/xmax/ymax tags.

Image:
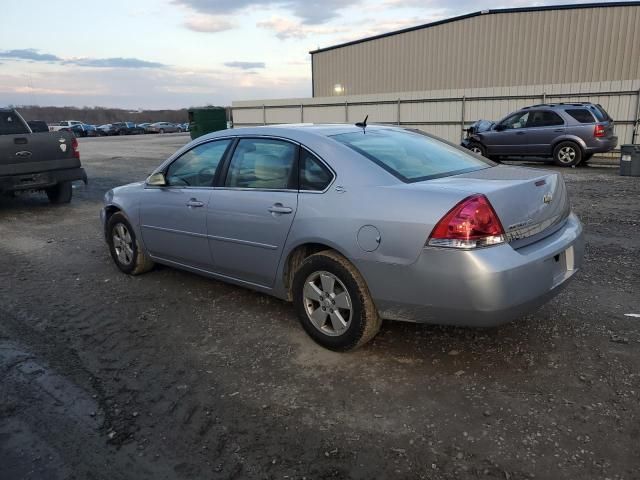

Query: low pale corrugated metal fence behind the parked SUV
<box><xmin>231</xmin><ymin>80</ymin><xmax>640</xmax><ymax>149</ymax></box>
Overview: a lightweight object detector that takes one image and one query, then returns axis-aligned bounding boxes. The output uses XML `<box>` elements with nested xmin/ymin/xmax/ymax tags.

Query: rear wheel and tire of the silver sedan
<box><xmin>292</xmin><ymin>250</ymin><xmax>382</xmax><ymax>352</ymax></box>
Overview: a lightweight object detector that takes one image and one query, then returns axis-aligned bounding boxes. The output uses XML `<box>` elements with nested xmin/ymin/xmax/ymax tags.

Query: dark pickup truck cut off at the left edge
<box><xmin>0</xmin><ymin>108</ymin><xmax>87</xmax><ymax>203</ymax></box>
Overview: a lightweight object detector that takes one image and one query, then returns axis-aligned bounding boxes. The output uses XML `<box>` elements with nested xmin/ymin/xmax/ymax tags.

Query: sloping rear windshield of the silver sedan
<box><xmin>331</xmin><ymin>130</ymin><xmax>492</xmax><ymax>183</ymax></box>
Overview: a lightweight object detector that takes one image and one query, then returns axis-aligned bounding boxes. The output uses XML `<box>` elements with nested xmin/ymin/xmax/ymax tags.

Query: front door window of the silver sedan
<box><xmin>165</xmin><ymin>139</ymin><xmax>231</xmax><ymax>187</ymax></box>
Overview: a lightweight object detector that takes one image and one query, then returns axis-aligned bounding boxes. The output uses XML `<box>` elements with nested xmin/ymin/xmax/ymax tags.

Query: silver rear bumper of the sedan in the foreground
<box><xmin>358</xmin><ymin>214</ymin><xmax>584</xmax><ymax>327</ymax></box>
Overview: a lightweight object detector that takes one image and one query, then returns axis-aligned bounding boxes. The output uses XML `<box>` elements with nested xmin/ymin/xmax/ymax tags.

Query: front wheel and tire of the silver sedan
<box><xmin>107</xmin><ymin>212</ymin><xmax>155</xmax><ymax>275</ymax></box>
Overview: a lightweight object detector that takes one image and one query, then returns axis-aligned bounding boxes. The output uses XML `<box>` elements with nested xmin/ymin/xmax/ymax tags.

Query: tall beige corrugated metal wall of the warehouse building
<box><xmin>312</xmin><ymin>4</ymin><xmax>640</xmax><ymax>97</ymax></box>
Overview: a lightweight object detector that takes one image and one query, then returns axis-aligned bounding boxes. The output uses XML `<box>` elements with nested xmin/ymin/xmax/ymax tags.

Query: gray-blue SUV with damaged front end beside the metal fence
<box><xmin>462</xmin><ymin>103</ymin><xmax>618</xmax><ymax>167</ymax></box>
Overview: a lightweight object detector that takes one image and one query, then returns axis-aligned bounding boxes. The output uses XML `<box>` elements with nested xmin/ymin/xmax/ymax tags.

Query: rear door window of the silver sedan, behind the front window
<box><xmin>225</xmin><ymin>138</ymin><xmax>298</xmax><ymax>190</ymax></box>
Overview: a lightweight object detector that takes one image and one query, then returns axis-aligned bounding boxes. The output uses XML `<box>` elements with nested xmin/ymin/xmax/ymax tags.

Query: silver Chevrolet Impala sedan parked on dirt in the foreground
<box><xmin>101</xmin><ymin>125</ymin><xmax>584</xmax><ymax>350</ymax></box>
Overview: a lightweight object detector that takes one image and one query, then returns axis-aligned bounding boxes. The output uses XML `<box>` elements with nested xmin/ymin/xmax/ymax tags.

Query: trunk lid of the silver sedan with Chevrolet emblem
<box><xmin>428</xmin><ymin>165</ymin><xmax>571</xmax><ymax>248</ymax></box>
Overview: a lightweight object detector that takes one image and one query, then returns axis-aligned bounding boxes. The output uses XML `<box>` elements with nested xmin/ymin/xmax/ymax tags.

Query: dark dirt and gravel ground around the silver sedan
<box><xmin>0</xmin><ymin>135</ymin><xmax>640</xmax><ymax>480</ymax></box>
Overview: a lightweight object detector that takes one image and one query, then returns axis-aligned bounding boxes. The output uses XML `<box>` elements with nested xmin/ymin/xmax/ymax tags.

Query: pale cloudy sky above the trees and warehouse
<box><xmin>0</xmin><ymin>0</ymin><xmax>632</xmax><ymax>110</ymax></box>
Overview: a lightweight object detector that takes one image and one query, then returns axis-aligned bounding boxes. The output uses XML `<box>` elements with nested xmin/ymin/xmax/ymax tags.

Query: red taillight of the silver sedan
<box><xmin>427</xmin><ymin>194</ymin><xmax>504</xmax><ymax>248</ymax></box>
